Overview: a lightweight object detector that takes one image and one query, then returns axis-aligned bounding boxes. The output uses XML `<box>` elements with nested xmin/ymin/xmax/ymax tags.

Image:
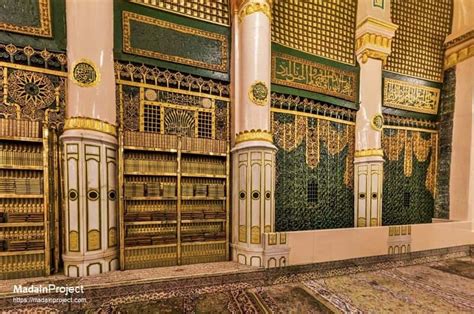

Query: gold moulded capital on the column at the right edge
<box><xmin>444</xmin><ymin>30</ymin><xmax>474</xmax><ymax>69</ymax></box>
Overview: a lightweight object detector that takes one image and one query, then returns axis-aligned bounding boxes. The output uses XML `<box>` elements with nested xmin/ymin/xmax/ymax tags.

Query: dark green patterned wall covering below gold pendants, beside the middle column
<box><xmin>274</xmin><ymin>113</ymin><xmax>354</xmax><ymax>231</ymax></box>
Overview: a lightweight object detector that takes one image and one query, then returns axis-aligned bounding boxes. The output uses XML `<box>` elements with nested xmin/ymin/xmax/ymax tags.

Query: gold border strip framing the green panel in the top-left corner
<box><xmin>0</xmin><ymin>0</ymin><xmax>53</xmax><ymax>37</ymax></box>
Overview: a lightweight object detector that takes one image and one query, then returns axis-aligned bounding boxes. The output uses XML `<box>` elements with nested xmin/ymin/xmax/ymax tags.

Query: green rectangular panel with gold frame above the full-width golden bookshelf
<box><xmin>114</xmin><ymin>0</ymin><xmax>230</xmax><ymax>81</ymax></box>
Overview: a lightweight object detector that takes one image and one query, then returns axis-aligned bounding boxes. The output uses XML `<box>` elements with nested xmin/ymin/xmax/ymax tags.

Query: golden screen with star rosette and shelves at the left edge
<box><xmin>0</xmin><ymin>45</ymin><xmax>67</xmax><ymax>279</ymax></box>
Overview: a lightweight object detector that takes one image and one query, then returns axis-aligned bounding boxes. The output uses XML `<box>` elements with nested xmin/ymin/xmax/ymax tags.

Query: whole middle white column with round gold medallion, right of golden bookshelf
<box><xmin>232</xmin><ymin>0</ymin><xmax>288</xmax><ymax>267</ymax></box>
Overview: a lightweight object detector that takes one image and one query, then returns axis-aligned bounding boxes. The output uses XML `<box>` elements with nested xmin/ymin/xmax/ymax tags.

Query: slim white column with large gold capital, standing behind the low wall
<box><xmin>354</xmin><ymin>0</ymin><xmax>397</xmax><ymax>227</ymax></box>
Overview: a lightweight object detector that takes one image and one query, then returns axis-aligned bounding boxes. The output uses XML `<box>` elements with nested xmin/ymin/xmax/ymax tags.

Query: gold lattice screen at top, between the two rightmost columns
<box><xmin>385</xmin><ymin>0</ymin><xmax>453</xmax><ymax>82</ymax></box>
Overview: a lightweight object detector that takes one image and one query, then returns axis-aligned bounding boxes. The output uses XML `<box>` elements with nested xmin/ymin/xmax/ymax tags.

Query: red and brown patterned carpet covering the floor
<box><xmin>1</xmin><ymin>256</ymin><xmax>474</xmax><ymax>314</ymax></box>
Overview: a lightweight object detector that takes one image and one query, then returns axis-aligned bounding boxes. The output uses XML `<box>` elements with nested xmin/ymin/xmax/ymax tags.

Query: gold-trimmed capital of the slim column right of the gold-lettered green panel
<box><xmin>356</xmin><ymin>16</ymin><xmax>398</xmax><ymax>65</ymax></box>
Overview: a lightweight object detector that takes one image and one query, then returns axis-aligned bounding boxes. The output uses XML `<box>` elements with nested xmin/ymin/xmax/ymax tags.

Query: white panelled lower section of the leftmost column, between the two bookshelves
<box><xmin>61</xmin><ymin>129</ymin><xmax>119</xmax><ymax>277</ymax></box>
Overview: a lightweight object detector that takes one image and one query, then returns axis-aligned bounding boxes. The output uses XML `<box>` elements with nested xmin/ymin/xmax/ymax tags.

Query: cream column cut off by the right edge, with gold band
<box><xmin>445</xmin><ymin>0</ymin><xmax>474</xmax><ymax>228</ymax></box>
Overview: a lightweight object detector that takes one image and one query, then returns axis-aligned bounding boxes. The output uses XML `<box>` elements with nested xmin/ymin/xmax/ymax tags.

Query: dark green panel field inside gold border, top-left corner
<box><xmin>0</xmin><ymin>0</ymin><xmax>41</xmax><ymax>27</ymax></box>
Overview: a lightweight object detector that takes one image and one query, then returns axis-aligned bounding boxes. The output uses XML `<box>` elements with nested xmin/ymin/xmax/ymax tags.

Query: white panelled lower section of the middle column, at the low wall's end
<box><xmin>232</xmin><ymin>140</ymin><xmax>289</xmax><ymax>267</ymax></box>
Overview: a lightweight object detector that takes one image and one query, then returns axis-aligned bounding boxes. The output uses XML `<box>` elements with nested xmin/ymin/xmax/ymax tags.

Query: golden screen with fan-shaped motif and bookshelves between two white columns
<box><xmin>116</xmin><ymin>63</ymin><xmax>229</xmax><ymax>269</ymax></box>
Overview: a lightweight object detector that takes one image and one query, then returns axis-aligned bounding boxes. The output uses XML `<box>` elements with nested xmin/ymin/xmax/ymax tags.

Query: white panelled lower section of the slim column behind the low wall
<box><xmin>354</xmin><ymin>150</ymin><xmax>384</xmax><ymax>227</ymax></box>
